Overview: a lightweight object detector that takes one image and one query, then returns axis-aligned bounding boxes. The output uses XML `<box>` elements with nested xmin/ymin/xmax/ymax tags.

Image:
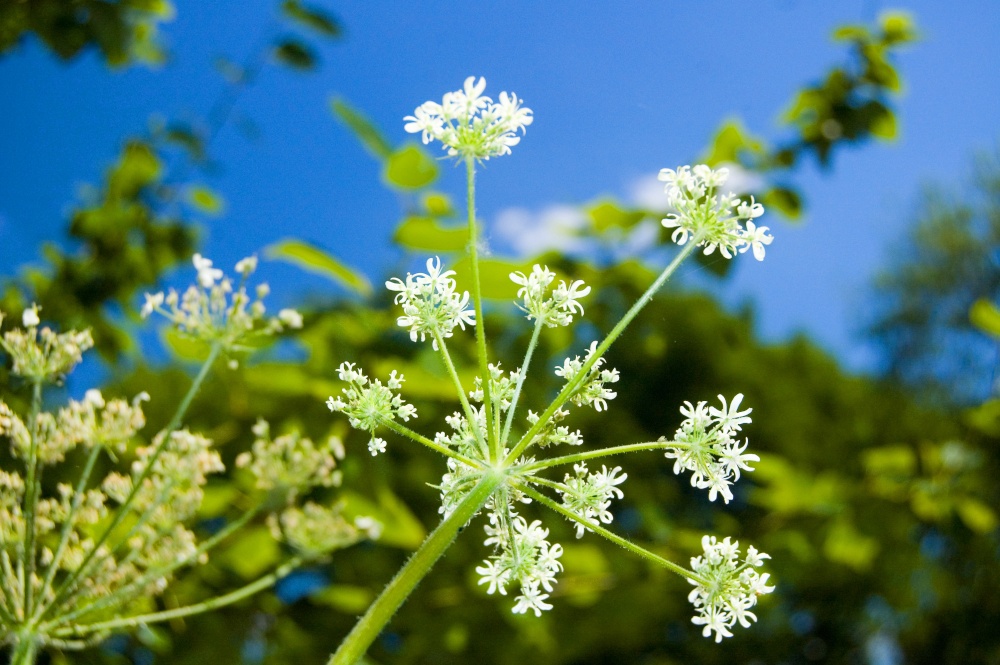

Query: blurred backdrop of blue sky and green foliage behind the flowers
<box><xmin>0</xmin><ymin>0</ymin><xmax>1000</xmax><ymax>664</ymax></box>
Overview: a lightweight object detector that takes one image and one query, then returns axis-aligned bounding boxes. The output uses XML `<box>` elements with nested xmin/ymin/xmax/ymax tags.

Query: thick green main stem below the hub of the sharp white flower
<box><xmin>328</xmin><ymin>471</ymin><xmax>505</xmax><ymax>665</ymax></box>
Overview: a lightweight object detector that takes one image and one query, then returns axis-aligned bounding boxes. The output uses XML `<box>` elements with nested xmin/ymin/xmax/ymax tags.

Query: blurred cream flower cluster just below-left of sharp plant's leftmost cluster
<box><xmin>236</xmin><ymin>419</ymin><xmax>344</xmax><ymax>499</ymax></box>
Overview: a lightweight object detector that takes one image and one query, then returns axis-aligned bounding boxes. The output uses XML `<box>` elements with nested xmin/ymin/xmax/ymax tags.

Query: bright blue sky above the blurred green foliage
<box><xmin>0</xmin><ymin>0</ymin><xmax>1000</xmax><ymax>370</ymax></box>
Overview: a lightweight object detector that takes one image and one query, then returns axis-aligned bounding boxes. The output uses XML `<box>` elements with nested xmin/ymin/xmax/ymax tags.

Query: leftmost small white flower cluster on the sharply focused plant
<box><xmin>326</xmin><ymin>363</ymin><xmax>417</xmax><ymax>456</ymax></box>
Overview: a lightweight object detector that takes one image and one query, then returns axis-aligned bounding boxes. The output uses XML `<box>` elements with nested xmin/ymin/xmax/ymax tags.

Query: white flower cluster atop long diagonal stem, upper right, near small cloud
<box><xmin>658</xmin><ymin>164</ymin><xmax>774</xmax><ymax>261</ymax></box>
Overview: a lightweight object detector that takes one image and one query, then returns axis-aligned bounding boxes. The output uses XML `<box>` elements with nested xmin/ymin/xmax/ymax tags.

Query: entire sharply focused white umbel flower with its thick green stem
<box><xmin>327</xmin><ymin>77</ymin><xmax>773</xmax><ymax>665</ymax></box>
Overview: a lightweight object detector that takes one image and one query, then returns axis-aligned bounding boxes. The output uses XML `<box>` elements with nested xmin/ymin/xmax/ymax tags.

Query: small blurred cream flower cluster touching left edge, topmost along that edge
<box><xmin>0</xmin><ymin>305</ymin><xmax>94</xmax><ymax>382</ymax></box>
